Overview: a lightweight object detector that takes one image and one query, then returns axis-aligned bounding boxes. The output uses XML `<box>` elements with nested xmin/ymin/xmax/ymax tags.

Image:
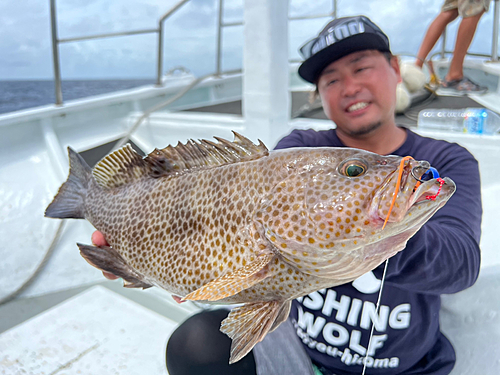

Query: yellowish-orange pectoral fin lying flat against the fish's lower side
<box><xmin>182</xmin><ymin>254</ymin><xmax>275</xmax><ymax>301</ymax></box>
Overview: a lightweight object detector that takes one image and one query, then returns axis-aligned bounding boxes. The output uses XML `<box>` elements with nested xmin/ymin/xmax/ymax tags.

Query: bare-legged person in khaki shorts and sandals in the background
<box><xmin>415</xmin><ymin>0</ymin><xmax>490</xmax><ymax>94</ymax></box>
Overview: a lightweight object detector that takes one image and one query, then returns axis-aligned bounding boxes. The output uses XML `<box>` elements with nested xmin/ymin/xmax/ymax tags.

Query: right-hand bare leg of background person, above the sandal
<box><xmin>446</xmin><ymin>11</ymin><xmax>484</xmax><ymax>81</ymax></box>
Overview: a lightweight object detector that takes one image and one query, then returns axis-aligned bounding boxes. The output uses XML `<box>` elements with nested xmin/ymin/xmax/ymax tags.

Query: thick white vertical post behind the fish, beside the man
<box><xmin>242</xmin><ymin>0</ymin><xmax>290</xmax><ymax>147</ymax></box>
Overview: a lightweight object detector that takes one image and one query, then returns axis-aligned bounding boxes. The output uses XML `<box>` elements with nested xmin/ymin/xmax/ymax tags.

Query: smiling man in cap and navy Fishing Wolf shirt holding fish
<box><xmin>93</xmin><ymin>16</ymin><xmax>482</xmax><ymax>375</ymax></box>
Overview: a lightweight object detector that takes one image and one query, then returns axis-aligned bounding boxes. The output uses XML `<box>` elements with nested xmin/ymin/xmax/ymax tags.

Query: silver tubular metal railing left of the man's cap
<box><xmin>50</xmin><ymin>0</ymin><xmax>337</xmax><ymax>105</ymax></box>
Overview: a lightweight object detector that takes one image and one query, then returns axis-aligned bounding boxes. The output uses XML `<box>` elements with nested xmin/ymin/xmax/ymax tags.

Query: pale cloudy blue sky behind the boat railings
<box><xmin>0</xmin><ymin>0</ymin><xmax>493</xmax><ymax>80</ymax></box>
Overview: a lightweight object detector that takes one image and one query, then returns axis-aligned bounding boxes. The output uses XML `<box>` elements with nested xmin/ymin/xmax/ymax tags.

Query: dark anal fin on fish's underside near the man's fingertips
<box><xmin>77</xmin><ymin>244</ymin><xmax>153</xmax><ymax>289</ymax></box>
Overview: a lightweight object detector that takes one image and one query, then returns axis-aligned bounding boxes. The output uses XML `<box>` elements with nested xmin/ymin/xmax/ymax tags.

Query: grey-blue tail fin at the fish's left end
<box><xmin>45</xmin><ymin>147</ymin><xmax>92</xmax><ymax>219</ymax></box>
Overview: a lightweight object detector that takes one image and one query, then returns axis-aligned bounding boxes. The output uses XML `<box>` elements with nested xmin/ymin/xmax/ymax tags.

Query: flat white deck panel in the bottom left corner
<box><xmin>0</xmin><ymin>286</ymin><xmax>177</xmax><ymax>375</ymax></box>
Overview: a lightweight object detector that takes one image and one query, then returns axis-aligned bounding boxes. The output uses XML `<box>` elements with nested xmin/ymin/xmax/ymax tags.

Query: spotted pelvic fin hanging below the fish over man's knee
<box><xmin>220</xmin><ymin>301</ymin><xmax>291</xmax><ymax>363</ymax></box>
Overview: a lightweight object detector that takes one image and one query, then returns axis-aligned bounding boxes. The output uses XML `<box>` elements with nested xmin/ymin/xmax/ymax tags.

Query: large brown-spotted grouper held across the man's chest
<box><xmin>45</xmin><ymin>133</ymin><xmax>455</xmax><ymax>363</ymax></box>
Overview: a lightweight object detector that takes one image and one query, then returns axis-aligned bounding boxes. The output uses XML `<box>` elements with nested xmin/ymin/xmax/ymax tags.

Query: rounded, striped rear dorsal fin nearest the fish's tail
<box><xmin>92</xmin><ymin>144</ymin><xmax>149</xmax><ymax>189</ymax></box>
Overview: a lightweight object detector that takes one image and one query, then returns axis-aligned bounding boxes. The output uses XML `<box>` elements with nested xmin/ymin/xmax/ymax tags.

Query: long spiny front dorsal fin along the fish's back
<box><xmin>144</xmin><ymin>132</ymin><xmax>269</xmax><ymax>177</ymax></box>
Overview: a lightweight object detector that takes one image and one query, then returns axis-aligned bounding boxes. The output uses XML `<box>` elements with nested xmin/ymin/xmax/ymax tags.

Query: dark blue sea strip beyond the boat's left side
<box><xmin>0</xmin><ymin>79</ymin><xmax>155</xmax><ymax>114</ymax></box>
